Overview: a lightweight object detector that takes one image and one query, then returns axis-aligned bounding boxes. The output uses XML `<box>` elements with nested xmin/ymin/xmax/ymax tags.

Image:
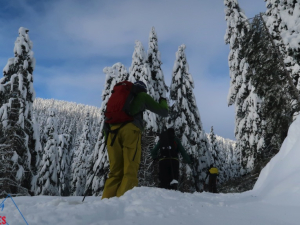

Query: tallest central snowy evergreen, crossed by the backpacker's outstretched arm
<box><xmin>137</xmin><ymin>27</ymin><xmax>168</xmax><ymax>186</ymax></box>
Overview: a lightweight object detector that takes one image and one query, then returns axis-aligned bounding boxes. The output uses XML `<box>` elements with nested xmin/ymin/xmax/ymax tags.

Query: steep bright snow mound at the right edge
<box><xmin>253</xmin><ymin>117</ymin><xmax>300</xmax><ymax>206</ymax></box>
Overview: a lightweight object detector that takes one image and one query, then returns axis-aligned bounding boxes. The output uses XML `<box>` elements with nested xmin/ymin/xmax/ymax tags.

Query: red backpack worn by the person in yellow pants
<box><xmin>104</xmin><ymin>81</ymin><xmax>134</xmax><ymax>124</ymax></box>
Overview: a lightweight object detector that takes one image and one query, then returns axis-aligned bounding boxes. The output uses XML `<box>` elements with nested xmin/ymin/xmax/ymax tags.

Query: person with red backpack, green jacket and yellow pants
<box><xmin>102</xmin><ymin>81</ymin><xmax>168</xmax><ymax>199</ymax></box>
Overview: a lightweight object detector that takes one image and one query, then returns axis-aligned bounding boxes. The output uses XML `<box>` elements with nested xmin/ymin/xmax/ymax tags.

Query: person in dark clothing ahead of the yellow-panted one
<box><xmin>151</xmin><ymin>128</ymin><xmax>191</xmax><ymax>190</ymax></box>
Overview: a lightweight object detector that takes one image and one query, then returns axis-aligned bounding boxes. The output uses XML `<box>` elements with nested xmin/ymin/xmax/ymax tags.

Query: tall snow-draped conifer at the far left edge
<box><xmin>0</xmin><ymin>27</ymin><xmax>39</xmax><ymax>194</ymax></box>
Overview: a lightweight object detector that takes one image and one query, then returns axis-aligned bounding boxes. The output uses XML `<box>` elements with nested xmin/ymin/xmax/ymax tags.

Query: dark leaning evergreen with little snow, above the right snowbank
<box><xmin>241</xmin><ymin>13</ymin><xmax>299</xmax><ymax>163</ymax></box>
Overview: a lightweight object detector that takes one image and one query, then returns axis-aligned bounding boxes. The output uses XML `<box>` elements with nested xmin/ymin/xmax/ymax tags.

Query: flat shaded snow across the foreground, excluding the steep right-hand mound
<box><xmin>0</xmin><ymin>187</ymin><xmax>299</xmax><ymax>225</ymax></box>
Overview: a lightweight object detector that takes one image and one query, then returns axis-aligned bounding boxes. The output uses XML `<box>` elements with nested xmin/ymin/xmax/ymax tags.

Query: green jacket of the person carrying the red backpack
<box><xmin>130</xmin><ymin>92</ymin><xmax>168</xmax><ymax>130</ymax></box>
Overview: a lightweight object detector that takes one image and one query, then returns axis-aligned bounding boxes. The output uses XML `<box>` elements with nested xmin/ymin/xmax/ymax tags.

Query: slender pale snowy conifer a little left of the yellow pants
<box><xmin>72</xmin><ymin>114</ymin><xmax>92</xmax><ymax>196</ymax></box>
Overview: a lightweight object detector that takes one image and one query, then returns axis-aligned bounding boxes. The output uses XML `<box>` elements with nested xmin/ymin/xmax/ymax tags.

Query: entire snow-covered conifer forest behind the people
<box><xmin>0</xmin><ymin>0</ymin><xmax>300</xmax><ymax>197</ymax></box>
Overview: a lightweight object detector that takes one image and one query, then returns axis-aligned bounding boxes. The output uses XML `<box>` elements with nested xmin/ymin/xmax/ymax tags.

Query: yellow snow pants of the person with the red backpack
<box><xmin>102</xmin><ymin>123</ymin><xmax>141</xmax><ymax>199</ymax></box>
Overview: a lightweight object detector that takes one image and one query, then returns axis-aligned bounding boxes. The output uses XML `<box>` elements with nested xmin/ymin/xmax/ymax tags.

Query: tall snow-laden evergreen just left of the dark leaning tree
<box><xmin>224</xmin><ymin>0</ymin><xmax>265</xmax><ymax>174</ymax></box>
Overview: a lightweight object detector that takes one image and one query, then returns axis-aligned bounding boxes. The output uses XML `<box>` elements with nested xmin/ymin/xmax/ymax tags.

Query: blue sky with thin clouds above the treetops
<box><xmin>0</xmin><ymin>0</ymin><xmax>266</xmax><ymax>139</ymax></box>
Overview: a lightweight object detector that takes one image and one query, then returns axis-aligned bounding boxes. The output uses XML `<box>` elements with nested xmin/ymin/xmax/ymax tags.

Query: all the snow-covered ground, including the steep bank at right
<box><xmin>0</xmin><ymin>118</ymin><xmax>300</xmax><ymax>225</ymax></box>
